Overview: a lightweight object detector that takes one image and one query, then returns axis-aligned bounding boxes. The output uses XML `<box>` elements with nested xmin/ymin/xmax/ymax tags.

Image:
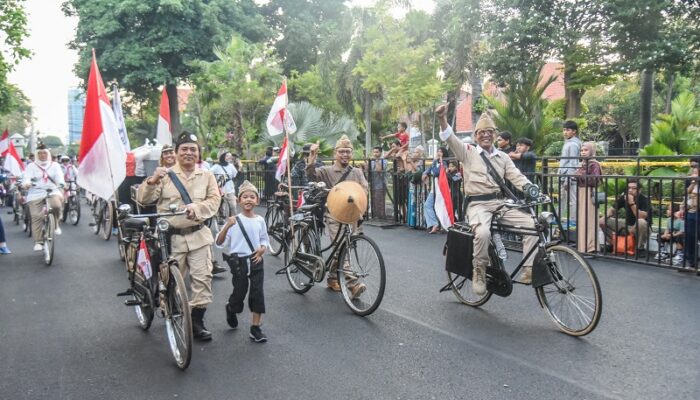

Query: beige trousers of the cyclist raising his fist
<box><xmin>467</xmin><ymin>200</ymin><xmax>539</xmax><ymax>268</ymax></box>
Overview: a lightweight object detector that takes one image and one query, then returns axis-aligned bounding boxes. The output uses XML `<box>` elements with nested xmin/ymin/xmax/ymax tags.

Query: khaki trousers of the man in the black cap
<box><xmin>172</xmin><ymin>245</ymin><xmax>213</xmax><ymax>308</ymax></box>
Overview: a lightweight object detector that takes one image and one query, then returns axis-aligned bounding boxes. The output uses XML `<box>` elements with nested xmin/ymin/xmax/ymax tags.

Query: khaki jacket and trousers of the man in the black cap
<box><xmin>136</xmin><ymin>164</ymin><xmax>221</xmax><ymax>307</ymax></box>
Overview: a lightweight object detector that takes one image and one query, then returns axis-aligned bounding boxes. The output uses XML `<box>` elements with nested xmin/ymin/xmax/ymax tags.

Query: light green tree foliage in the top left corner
<box><xmin>0</xmin><ymin>0</ymin><xmax>31</xmax><ymax>115</ymax></box>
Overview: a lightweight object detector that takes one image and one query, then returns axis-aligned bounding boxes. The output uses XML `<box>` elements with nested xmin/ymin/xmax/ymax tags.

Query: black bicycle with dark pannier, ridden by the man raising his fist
<box><xmin>440</xmin><ymin>196</ymin><xmax>603</xmax><ymax>336</ymax></box>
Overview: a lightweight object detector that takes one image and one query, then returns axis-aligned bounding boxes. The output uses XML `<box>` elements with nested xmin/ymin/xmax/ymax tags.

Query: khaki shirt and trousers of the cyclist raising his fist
<box><xmin>440</xmin><ymin>126</ymin><xmax>539</xmax><ymax>267</ymax></box>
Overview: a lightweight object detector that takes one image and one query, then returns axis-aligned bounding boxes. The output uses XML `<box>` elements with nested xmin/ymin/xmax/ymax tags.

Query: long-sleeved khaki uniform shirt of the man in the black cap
<box><xmin>136</xmin><ymin>164</ymin><xmax>221</xmax><ymax>253</ymax></box>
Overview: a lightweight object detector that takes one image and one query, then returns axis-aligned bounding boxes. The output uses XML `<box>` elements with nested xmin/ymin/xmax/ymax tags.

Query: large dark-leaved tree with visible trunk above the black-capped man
<box><xmin>63</xmin><ymin>0</ymin><xmax>269</xmax><ymax>133</ymax></box>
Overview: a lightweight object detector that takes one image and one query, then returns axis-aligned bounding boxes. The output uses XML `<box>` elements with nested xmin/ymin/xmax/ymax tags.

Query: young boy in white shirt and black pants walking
<box><xmin>216</xmin><ymin>181</ymin><xmax>270</xmax><ymax>343</ymax></box>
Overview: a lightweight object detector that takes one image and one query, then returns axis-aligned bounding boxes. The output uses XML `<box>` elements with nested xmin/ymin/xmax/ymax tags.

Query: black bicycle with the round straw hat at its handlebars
<box><xmin>278</xmin><ymin>183</ymin><xmax>386</xmax><ymax>316</ymax></box>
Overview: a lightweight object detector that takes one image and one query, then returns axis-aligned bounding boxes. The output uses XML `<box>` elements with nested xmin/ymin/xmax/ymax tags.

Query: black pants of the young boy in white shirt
<box><xmin>227</xmin><ymin>256</ymin><xmax>265</xmax><ymax>314</ymax></box>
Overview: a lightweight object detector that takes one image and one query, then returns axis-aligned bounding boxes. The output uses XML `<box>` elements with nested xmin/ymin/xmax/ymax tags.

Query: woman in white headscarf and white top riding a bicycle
<box><xmin>22</xmin><ymin>144</ymin><xmax>66</xmax><ymax>251</ymax></box>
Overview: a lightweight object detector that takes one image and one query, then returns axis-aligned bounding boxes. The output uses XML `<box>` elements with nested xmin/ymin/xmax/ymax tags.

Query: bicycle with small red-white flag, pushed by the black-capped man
<box><xmin>117</xmin><ymin>204</ymin><xmax>192</xmax><ymax>369</ymax></box>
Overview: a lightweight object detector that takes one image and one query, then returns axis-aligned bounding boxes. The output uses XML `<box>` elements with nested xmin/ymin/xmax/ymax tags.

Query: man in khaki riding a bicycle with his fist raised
<box><xmin>435</xmin><ymin>105</ymin><xmax>538</xmax><ymax>296</ymax></box>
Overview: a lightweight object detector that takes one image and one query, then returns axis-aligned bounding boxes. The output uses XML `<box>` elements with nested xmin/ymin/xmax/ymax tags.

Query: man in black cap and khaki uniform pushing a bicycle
<box><xmin>137</xmin><ymin>132</ymin><xmax>221</xmax><ymax>340</ymax></box>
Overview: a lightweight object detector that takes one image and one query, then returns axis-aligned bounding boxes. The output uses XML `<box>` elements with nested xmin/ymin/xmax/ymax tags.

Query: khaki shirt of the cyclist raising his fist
<box><xmin>440</xmin><ymin>126</ymin><xmax>531</xmax><ymax>196</ymax></box>
